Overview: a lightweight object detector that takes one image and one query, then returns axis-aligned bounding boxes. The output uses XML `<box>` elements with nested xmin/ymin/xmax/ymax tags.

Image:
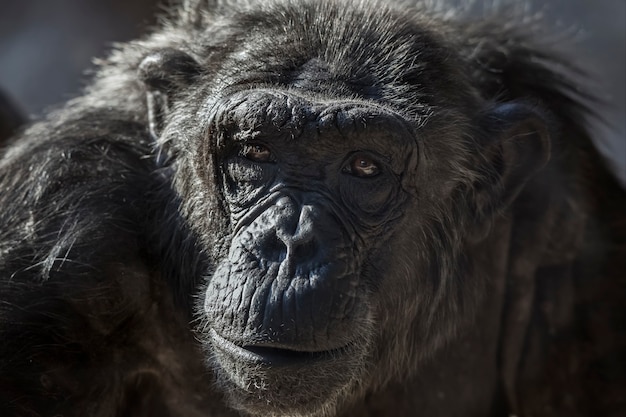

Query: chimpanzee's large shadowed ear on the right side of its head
<box><xmin>473</xmin><ymin>103</ymin><xmax>554</xmax><ymax>237</ymax></box>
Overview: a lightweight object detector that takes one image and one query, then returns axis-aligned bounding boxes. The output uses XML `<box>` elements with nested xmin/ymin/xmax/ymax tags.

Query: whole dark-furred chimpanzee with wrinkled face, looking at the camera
<box><xmin>0</xmin><ymin>1</ymin><xmax>626</xmax><ymax>417</ymax></box>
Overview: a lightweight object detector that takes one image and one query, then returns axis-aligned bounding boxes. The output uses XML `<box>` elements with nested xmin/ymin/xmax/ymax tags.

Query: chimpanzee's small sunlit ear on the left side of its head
<box><xmin>138</xmin><ymin>48</ymin><xmax>201</xmax><ymax>139</ymax></box>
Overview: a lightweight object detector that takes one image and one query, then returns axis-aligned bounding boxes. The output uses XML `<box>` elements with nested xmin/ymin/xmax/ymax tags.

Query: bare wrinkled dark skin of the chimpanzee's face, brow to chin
<box><xmin>197</xmin><ymin>90</ymin><xmax>417</xmax><ymax>407</ymax></box>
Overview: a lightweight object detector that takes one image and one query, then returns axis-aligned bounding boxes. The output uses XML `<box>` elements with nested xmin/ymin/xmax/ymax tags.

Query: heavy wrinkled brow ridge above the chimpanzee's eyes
<box><xmin>209</xmin><ymin>89</ymin><xmax>416</xmax><ymax>148</ymax></box>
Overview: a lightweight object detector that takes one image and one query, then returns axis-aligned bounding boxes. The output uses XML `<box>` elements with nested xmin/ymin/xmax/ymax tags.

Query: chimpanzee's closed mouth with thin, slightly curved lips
<box><xmin>210</xmin><ymin>329</ymin><xmax>349</xmax><ymax>367</ymax></box>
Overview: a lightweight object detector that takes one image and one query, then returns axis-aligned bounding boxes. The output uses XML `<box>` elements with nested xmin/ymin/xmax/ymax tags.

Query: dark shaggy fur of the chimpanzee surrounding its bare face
<box><xmin>0</xmin><ymin>1</ymin><xmax>626</xmax><ymax>417</ymax></box>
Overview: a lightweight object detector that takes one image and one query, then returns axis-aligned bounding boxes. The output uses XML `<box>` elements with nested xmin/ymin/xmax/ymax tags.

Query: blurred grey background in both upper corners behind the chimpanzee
<box><xmin>0</xmin><ymin>0</ymin><xmax>626</xmax><ymax>181</ymax></box>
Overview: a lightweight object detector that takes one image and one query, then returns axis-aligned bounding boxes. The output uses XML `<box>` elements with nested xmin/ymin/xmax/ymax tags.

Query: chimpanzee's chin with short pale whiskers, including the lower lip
<box><xmin>209</xmin><ymin>330</ymin><xmax>367</xmax><ymax>417</ymax></box>
